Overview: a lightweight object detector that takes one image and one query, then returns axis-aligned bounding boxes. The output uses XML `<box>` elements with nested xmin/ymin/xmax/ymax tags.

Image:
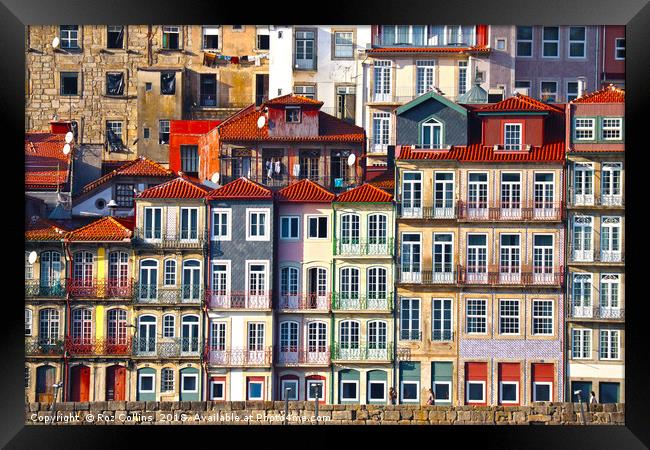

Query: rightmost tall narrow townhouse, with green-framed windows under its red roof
<box><xmin>566</xmin><ymin>85</ymin><xmax>626</xmax><ymax>403</ymax></box>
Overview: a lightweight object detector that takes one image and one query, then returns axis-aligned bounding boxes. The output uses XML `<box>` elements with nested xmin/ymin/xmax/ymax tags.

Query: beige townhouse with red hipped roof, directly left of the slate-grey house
<box><xmin>129</xmin><ymin>176</ymin><xmax>205</xmax><ymax>401</ymax></box>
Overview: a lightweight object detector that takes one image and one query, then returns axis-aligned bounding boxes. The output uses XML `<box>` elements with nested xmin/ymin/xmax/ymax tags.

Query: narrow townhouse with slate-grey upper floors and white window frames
<box><xmin>204</xmin><ymin>177</ymin><xmax>275</xmax><ymax>401</ymax></box>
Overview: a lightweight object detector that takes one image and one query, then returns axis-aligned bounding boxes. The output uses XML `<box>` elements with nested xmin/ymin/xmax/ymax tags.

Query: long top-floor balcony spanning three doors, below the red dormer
<box><xmin>458</xmin><ymin>201</ymin><xmax>564</xmax><ymax>222</ymax></box>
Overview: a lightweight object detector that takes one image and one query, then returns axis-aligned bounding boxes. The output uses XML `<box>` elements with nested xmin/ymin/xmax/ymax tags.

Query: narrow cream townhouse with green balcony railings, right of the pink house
<box><xmin>331</xmin><ymin>184</ymin><xmax>395</xmax><ymax>404</ymax></box>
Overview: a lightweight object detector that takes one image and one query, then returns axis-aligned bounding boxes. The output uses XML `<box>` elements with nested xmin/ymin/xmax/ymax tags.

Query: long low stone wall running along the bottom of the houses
<box><xmin>25</xmin><ymin>401</ymin><xmax>625</xmax><ymax>425</ymax></box>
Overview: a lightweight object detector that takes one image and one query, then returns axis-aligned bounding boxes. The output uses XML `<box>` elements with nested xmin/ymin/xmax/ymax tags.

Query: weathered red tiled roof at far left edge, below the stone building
<box><xmin>25</xmin><ymin>132</ymin><xmax>72</xmax><ymax>189</ymax></box>
